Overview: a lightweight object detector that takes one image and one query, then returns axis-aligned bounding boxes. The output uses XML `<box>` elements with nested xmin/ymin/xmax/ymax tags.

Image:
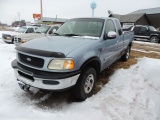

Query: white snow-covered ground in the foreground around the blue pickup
<box><xmin>0</xmin><ymin>31</ymin><xmax>160</xmax><ymax>120</ymax></box>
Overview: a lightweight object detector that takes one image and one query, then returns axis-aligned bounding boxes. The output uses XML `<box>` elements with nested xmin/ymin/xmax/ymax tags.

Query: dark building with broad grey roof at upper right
<box><xmin>109</xmin><ymin>7</ymin><xmax>160</xmax><ymax>28</ymax></box>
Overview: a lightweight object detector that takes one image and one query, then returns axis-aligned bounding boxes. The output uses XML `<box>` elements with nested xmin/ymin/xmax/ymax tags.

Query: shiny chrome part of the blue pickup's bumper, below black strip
<box><xmin>14</xmin><ymin>69</ymin><xmax>80</xmax><ymax>90</ymax></box>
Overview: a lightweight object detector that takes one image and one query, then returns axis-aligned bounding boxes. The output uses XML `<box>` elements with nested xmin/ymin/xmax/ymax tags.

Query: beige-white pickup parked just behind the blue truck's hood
<box><xmin>14</xmin><ymin>24</ymin><xmax>61</xmax><ymax>46</ymax></box>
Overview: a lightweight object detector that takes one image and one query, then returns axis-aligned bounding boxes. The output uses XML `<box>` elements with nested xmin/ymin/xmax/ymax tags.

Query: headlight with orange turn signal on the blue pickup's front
<box><xmin>48</xmin><ymin>59</ymin><xmax>74</xmax><ymax>70</ymax></box>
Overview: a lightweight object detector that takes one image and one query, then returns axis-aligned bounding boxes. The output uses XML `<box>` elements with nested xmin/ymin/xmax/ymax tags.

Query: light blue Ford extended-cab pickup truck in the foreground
<box><xmin>12</xmin><ymin>18</ymin><xmax>134</xmax><ymax>100</ymax></box>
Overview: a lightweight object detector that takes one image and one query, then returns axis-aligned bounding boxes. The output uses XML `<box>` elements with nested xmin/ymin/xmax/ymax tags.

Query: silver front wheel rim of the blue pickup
<box><xmin>84</xmin><ymin>74</ymin><xmax>94</xmax><ymax>93</ymax></box>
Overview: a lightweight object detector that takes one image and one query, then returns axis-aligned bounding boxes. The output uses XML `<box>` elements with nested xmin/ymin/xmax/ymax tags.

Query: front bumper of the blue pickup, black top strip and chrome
<box><xmin>12</xmin><ymin>60</ymin><xmax>80</xmax><ymax>91</ymax></box>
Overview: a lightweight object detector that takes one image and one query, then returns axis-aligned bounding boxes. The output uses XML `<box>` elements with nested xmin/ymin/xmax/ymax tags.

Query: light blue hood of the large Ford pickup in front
<box><xmin>21</xmin><ymin>36</ymin><xmax>95</xmax><ymax>56</ymax></box>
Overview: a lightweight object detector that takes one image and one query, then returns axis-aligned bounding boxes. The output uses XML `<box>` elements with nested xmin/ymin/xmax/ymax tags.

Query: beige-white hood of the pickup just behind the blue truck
<box><xmin>16</xmin><ymin>33</ymin><xmax>45</xmax><ymax>41</ymax></box>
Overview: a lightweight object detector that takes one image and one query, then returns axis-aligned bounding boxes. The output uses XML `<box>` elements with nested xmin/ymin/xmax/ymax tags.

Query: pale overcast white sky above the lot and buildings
<box><xmin>0</xmin><ymin>0</ymin><xmax>160</xmax><ymax>24</ymax></box>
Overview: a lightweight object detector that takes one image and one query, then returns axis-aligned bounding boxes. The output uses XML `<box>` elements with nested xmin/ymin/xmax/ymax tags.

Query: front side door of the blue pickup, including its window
<box><xmin>102</xmin><ymin>19</ymin><xmax>123</xmax><ymax>69</ymax></box>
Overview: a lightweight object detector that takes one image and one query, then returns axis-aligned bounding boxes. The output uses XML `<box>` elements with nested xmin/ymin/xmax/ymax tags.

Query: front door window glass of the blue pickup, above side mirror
<box><xmin>105</xmin><ymin>20</ymin><xmax>116</xmax><ymax>34</ymax></box>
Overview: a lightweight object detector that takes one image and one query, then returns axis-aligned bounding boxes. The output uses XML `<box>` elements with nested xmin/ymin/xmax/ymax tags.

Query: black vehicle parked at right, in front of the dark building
<box><xmin>123</xmin><ymin>25</ymin><xmax>160</xmax><ymax>43</ymax></box>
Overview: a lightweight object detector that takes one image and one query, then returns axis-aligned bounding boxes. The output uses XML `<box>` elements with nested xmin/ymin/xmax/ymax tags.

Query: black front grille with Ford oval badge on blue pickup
<box><xmin>18</xmin><ymin>53</ymin><xmax>44</xmax><ymax>68</ymax></box>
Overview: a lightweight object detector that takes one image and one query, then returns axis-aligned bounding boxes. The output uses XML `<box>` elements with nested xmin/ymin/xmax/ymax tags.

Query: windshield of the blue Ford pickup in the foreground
<box><xmin>56</xmin><ymin>18</ymin><xmax>104</xmax><ymax>37</ymax></box>
